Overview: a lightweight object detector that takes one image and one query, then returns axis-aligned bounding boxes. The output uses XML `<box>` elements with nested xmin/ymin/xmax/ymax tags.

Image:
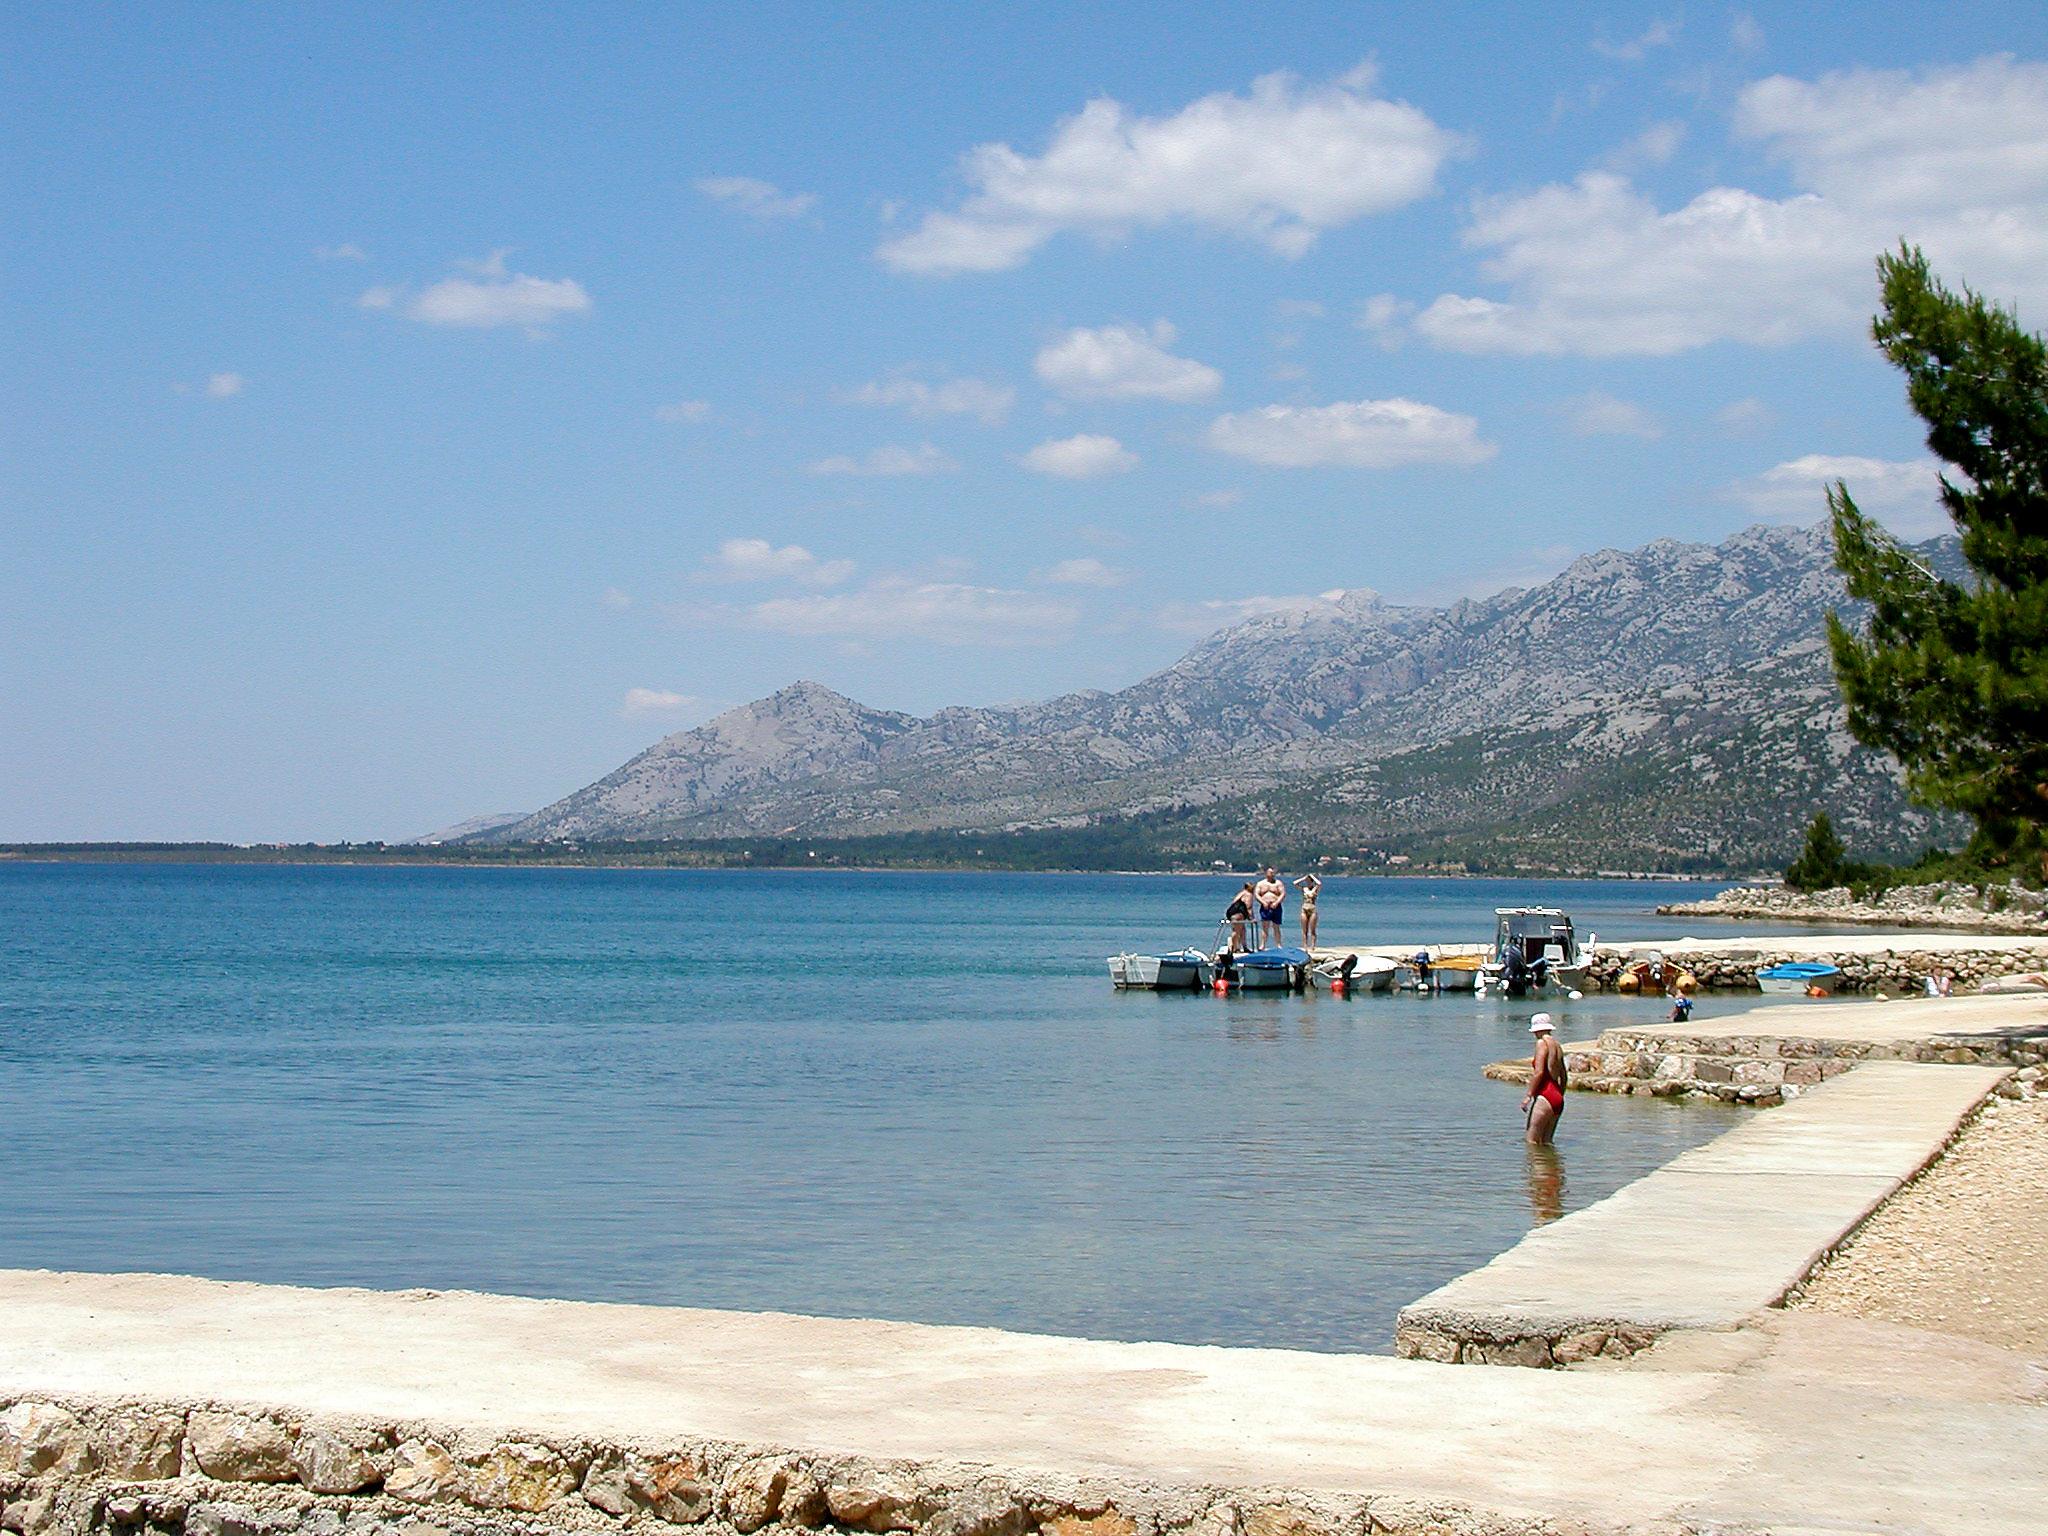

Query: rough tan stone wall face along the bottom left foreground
<box><xmin>0</xmin><ymin>1399</ymin><xmax>1554</xmax><ymax>1536</ymax></box>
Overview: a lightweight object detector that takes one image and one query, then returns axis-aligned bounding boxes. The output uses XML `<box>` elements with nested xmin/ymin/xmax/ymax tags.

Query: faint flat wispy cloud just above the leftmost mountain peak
<box><xmin>743</xmin><ymin>578</ymin><xmax>1081</xmax><ymax>645</ymax></box>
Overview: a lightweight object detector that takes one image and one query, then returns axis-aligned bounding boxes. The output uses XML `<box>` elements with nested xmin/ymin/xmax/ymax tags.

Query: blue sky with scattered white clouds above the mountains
<box><xmin>0</xmin><ymin>0</ymin><xmax>2048</xmax><ymax>842</ymax></box>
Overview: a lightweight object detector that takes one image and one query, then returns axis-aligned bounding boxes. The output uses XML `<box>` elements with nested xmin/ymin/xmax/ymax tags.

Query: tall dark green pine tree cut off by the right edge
<box><xmin>1827</xmin><ymin>246</ymin><xmax>2048</xmax><ymax>874</ymax></box>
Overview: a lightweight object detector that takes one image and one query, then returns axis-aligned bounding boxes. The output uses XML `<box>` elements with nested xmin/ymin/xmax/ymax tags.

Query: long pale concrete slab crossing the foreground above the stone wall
<box><xmin>0</xmin><ymin>1272</ymin><xmax>2048</xmax><ymax>1536</ymax></box>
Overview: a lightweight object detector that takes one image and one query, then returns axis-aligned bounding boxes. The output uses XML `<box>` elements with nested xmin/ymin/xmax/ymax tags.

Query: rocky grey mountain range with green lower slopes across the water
<box><xmin>456</xmin><ymin>526</ymin><xmax>1958</xmax><ymax>870</ymax></box>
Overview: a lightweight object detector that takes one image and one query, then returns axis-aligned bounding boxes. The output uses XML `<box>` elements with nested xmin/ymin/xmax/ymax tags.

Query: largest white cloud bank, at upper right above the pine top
<box><xmin>1413</xmin><ymin>57</ymin><xmax>2048</xmax><ymax>356</ymax></box>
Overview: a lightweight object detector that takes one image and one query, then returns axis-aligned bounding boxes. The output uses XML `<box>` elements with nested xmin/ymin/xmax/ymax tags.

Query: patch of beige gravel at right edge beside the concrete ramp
<box><xmin>1794</xmin><ymin>1098</ymin><xmax>2048</xmax><ymax>1358</ymax></box>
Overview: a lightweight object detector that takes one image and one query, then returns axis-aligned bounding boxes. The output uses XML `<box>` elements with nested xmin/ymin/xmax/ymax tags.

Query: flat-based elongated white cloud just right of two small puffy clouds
<box><xmin>1204</xmin><ymin>399</ymin><xmax>1497</xmax><ymax>469</ymax></box>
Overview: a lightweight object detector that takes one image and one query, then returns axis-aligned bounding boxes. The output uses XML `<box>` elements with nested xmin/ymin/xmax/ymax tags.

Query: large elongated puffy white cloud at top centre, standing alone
<box><xmin>877</xmin><ymin>68</ymin><xmax>1458</xmax><ymax>276</ymax></box>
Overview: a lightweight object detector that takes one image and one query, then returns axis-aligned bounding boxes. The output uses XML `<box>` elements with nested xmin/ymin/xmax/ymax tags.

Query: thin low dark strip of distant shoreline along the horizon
<box><xmin>0</xmin><ymin>844</ymin><xmax>1753</xmax><ymax>885</ymax></box>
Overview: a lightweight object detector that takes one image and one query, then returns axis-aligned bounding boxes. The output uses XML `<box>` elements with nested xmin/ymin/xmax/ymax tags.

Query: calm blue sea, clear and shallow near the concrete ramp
<box><xmin>0</xmin><ymin>864</ymin><xmax>1826</xmax><ymax>1350</ymax></box>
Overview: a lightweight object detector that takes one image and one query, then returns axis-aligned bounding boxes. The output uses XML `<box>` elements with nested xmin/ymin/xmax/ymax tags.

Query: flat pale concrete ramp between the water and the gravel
<box><xmin>1395</xmin><ymin>1061</ymin><xmax>2005</xmax><ymax>1366</ymax></box>
